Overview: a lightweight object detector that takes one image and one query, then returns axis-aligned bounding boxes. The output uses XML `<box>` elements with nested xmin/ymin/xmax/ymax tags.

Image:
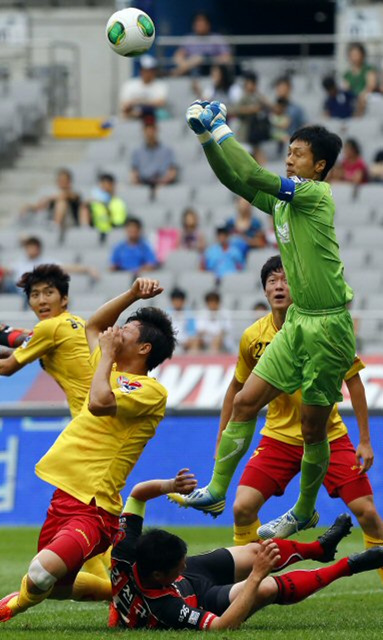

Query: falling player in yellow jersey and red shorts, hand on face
<box><xmin>0</xmin><ymin>279</ymin><xmax>176</xmax><ymax>622</ymax></box>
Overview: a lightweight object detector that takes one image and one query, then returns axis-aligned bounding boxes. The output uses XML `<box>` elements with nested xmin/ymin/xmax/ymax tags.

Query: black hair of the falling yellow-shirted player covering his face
<box><xmin>126</xmin><ymin>307</ymin><xmax>177</xmax><ymax>371</ymax></box>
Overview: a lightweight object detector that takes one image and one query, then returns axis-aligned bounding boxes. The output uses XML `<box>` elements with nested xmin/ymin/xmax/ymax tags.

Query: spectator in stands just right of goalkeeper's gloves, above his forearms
<box><xmin>229</xmin><ymin>71</ymin><xmax>271</xmax><ymax>163</ymax></box>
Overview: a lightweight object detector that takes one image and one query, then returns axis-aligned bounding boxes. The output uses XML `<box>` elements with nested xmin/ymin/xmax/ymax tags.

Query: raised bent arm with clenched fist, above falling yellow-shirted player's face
<box><xmin>85</xmin><ymin>278</ymin><xmax>163</xmax><ymax>353</ymax></box>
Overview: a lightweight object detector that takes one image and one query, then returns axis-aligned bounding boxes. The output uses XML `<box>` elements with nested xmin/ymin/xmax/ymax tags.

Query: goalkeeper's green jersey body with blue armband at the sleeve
<box><xmin>253</xmin><ymin>177</ymin><xmax>353</xmax><ymax>312</ymax></box>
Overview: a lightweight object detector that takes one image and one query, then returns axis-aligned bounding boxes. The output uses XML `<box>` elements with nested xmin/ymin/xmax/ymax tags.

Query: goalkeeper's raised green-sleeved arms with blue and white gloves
<box><xmin>186</xmin><ymin>101</ymin><xmax>291</xmax><ymax>202</ymax></box>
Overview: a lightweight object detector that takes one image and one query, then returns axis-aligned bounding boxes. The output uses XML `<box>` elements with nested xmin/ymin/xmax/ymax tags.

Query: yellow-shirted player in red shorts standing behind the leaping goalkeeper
<box><xmin>169</xmin><ymin>256</ymin><xmax>383</xmax><ymax>579</ymax></box>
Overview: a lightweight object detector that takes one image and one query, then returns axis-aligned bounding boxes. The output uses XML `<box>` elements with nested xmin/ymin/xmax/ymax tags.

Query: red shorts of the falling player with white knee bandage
<box><xmin>38</xmin><ymin>489</ymin><xmax>119</xmax><ymax>584</ymax></box>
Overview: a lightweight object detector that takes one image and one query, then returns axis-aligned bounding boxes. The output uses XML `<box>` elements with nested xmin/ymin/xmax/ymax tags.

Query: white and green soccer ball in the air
<box><xmin>106</xmin><ymin>7</ymin><xmax>155</xmax><ymax>57</ymax></box>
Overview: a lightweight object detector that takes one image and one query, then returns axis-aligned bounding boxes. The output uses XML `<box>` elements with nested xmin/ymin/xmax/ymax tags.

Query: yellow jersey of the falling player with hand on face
<box><xmin>36</xmin><ymin>347</ymin><xmax>167</xmax><ymax>515</ymax></box>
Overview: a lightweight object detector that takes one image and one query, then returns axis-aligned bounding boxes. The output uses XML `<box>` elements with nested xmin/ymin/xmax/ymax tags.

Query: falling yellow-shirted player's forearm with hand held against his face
<box><xmin>88</xmin><ymin>327</ymin><xmax>122</xmax><ymax>416</ymax></box>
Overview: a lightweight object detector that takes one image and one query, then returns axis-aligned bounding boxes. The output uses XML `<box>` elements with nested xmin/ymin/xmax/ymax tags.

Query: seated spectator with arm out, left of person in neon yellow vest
<box><xmin>21</xmin><ymin>169</ymin><xmax>87</xmax><ymax>238</ymax></box>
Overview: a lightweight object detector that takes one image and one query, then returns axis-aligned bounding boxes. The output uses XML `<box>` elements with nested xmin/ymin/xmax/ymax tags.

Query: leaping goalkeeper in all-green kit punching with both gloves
<box><xmin>186</xmin><ymin>103</ymin><xmax>355</xmax><ymax>536</ymax></box>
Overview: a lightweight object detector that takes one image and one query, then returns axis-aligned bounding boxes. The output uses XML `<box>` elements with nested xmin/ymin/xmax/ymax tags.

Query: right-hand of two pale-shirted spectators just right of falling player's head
<box><xmin>169</xmin><ymin>287</ymin><xmax>199</xmax><ymax>353</ymax></box>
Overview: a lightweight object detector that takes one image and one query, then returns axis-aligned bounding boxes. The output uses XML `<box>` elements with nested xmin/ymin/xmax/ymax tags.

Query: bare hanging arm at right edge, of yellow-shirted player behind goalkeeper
<box><xmin>346</xmin><ymin>373</ymin><xmax>374</xmax><ymax>473</ymax></box>
